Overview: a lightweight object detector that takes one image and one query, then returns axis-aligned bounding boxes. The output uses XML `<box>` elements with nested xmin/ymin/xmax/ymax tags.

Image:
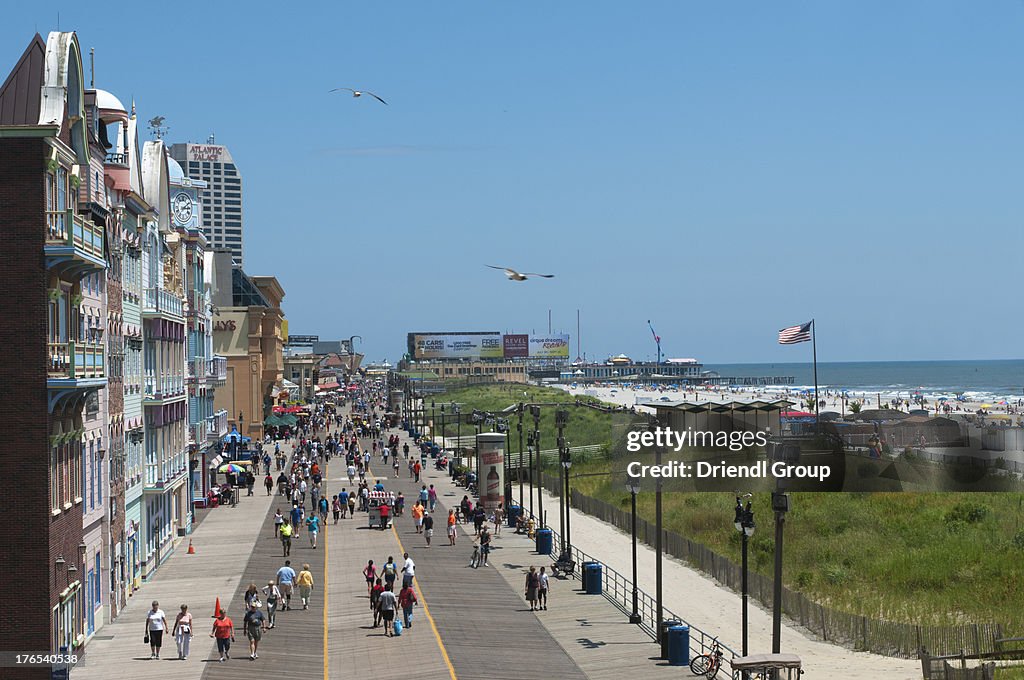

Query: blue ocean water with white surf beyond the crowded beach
<box><xmin>703</xmin><ymin>359</ymin><xmax>1024</xmax><ymax>400</ymax></box>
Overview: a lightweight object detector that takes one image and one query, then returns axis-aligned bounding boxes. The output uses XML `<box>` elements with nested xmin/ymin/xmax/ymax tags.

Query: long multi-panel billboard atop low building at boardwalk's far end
<box><xmin>409</xmin><ymin>332</ymin><xmax>569</xmax><ymax>362</ymax></box>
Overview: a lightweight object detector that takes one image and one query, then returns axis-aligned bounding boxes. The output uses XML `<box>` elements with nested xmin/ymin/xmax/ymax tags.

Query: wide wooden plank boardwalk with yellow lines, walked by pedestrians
<box><xmin>75</xmin><ymin>419</ymin><xmax>688</xmax><ymax>680</ymax></box>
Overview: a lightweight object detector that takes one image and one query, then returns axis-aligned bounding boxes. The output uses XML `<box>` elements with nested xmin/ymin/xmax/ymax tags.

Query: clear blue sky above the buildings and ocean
<box><xmin>0</xmin><ymin>0</ymin><xmax>1024</xmax><ymax>364</ymax></box>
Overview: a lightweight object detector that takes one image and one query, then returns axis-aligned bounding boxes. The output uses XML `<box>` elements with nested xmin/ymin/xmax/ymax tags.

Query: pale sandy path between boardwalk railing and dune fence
<box><xmin>528</xmin><ymin>485</ymin><xmax>921</xmax><ymax>680</ymax></box>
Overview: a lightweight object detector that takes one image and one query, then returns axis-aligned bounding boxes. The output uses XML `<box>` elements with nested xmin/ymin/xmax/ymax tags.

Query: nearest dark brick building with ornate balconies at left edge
<box><xmin>0</xmin><ymin>33</ymin><xmax>106</xmax><ymax>667</ymax></box>
